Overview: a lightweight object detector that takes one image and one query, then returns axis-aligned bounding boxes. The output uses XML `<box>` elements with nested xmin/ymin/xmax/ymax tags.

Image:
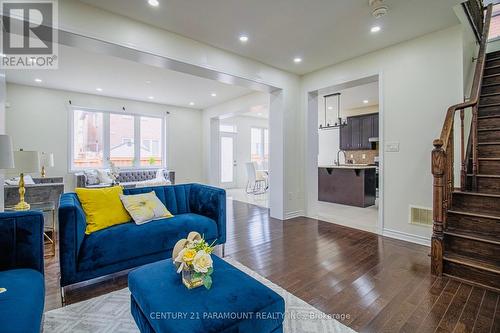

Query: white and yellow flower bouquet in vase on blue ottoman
<box><xmin>172</xmin><ymin>232</ymin><xmax>215</xmax><ymax>289</ymax></box>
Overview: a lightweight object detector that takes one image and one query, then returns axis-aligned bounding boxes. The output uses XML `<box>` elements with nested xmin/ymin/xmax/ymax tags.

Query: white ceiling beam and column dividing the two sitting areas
<box><xmin>59</xmin><ymin>0</ymin><xmax>304</xmax><ymax>218</ymax></box>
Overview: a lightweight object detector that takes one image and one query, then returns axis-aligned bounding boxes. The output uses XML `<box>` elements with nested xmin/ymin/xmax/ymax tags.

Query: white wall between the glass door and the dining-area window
<box><xmin>220</xmin><ymin>116</ymin><xmax>269</xmax><ymax>188</ymax></box>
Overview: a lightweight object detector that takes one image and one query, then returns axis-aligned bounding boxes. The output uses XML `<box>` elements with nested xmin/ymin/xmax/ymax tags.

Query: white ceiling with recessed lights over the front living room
<box><xmin>81</xmin><ymin>0</ymin><xmax>461</xmax><ymax>74</ymax></box>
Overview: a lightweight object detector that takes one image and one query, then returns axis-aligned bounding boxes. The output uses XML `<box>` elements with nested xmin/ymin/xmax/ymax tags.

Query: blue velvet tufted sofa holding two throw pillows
<box><xmin>59</xmin><ymin>184</ymin><xmax>226</xmax><ymax>288</ymax></box>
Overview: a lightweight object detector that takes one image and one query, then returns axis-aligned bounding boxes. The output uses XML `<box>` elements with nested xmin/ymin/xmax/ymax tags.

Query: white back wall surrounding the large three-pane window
<box><xmin>6</xmin><ymin>83</ymin><xmax>204</xmax><ymax>190</ymax></box>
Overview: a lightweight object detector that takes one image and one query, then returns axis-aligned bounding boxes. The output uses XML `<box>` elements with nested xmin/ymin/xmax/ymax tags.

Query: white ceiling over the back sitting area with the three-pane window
<box><xmin>6</xmin><ymin>45</ymin><xmax>253</xmax><ymax>109</ymax></box>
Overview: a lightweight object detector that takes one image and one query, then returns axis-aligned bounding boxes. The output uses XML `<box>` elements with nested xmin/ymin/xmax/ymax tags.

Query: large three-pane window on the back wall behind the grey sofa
<box><xmin>70</xmin><ymin>108</ymin><xmax>165</xmax><ymax>170</ymax></box>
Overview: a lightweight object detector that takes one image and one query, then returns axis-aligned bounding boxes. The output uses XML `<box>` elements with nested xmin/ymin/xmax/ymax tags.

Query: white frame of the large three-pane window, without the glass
<box><xmin>68</xmin><ymin>106</ymin><xmax>168</xmax><ymax>173</ymax></box>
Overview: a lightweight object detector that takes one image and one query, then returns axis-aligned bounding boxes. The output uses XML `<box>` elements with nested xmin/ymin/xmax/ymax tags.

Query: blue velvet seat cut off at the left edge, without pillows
<box><xmin>0</xmin><ymin>211</ymin><xmax>45</xmax><ymax>333</ymax></box>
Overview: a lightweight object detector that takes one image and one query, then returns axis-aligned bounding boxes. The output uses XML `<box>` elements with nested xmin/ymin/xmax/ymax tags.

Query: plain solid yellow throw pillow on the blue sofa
<box><xmin>75</xmin><ymin>186</ymin><xmax>130</xmax><ymax>235</ymax></box>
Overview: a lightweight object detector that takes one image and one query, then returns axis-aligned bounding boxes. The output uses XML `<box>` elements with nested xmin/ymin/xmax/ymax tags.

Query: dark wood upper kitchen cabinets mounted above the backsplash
<box><xmin>340</xmin><ymin>113</ymin><xmax>379</xmax><ymax>150</ymax></box>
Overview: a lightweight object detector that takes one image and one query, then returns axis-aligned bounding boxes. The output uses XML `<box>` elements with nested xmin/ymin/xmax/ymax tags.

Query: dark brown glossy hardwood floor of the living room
<box><xmin>46</xmin><ymin>201</ymin><xmax>500</xmax><ymax>333</ymax></box>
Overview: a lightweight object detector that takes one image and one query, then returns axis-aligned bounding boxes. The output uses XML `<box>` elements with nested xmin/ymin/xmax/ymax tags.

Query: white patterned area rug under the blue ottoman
<box><xmin>44</xmin><ymin>258</ymin><xmax>354</xmax><ymax>333</ymax></box>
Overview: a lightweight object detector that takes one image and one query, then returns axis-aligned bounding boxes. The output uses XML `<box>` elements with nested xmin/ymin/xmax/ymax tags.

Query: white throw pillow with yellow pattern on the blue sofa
<box><xmin>120</xmin><ymin>191</ymin><xmax>173</xmax><ymax>224</ymax></box>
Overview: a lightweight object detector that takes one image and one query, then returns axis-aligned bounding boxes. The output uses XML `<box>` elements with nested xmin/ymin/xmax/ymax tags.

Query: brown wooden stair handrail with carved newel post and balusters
<box><xmin>431</xmin><ymin>0</ymin><xmax>493</xmax><ymax>275</ymax></box>
